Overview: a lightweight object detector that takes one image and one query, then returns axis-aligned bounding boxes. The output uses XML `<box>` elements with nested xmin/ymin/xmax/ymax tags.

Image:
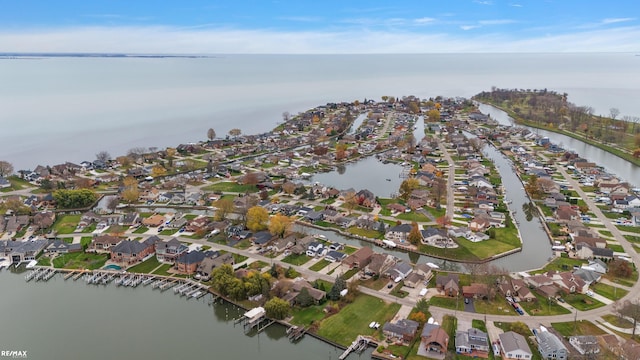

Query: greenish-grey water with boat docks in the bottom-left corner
<box><xmin>0</xmin><ymin>270</ymin><xmax>373</xmax><ymax>360</ymax></box>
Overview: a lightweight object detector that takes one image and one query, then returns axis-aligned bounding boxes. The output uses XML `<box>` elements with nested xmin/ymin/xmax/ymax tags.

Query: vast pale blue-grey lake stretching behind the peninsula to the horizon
<box><xmin>0</xmin><ymin>53</ymin><xmax>640</xmax><ymax>169</ymax></box>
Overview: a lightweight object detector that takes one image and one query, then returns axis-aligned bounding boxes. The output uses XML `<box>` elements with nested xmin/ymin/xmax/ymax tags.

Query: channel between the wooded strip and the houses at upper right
<box><xmin>479</xmin><ymin>104</ymin><xmax>640</xmax><ymax>186</ymax></box>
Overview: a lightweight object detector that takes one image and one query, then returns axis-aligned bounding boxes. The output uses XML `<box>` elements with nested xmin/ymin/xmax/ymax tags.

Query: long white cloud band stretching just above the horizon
<box><xmin>0</xmin><ymin>25</ymin><xmax>640</xmax><ymax>54</ymax></box>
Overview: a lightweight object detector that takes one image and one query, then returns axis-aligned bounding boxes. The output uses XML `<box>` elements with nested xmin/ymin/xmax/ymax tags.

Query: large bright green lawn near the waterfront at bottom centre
<box><xmin>318</xmin><ymin>295</ymin><xmax>400</xmax><ymax>346</ymax></box>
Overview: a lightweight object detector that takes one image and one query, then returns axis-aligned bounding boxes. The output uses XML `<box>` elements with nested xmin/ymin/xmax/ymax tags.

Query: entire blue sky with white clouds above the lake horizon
<box><xmin>0</xmin><ymin>0</ymin><xmax>640</xmax><ymax>54</ymax></box>
